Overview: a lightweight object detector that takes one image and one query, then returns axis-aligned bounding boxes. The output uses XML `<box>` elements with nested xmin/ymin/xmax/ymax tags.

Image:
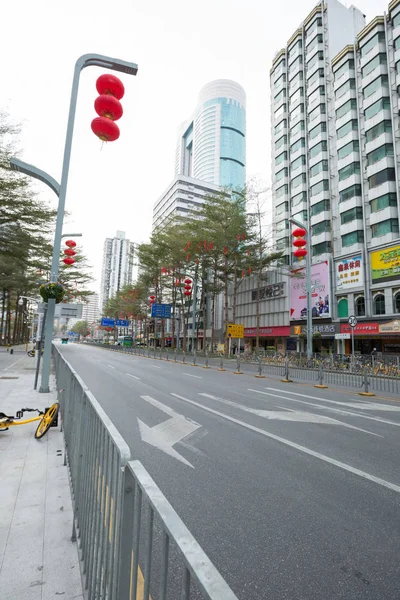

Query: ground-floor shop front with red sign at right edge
<box><xmin>340</xmin><ymin>320</ymin><xmax>400</xmax><ymax>355</ymax></box>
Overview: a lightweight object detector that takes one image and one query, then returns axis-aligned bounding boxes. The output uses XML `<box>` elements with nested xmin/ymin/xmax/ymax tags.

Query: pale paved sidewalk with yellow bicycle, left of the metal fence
<box><xmin>0</xmin><ymin>357</ymin><xmax>84</xmax><ymax>600</ymax></box>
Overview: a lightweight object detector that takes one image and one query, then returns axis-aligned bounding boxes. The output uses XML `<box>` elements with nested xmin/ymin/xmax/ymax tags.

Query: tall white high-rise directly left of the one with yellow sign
<box><xmin>270</xmin><ymin>0</ymin><xmax>365</xmax><ymax>263</ymax></box>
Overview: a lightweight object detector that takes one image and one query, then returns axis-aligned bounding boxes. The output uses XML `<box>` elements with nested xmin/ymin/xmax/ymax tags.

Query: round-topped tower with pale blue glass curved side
<box><xmin>175</xmin><ymin>79</ymin><xmax>246</xmax><ymax>190</ymax></box>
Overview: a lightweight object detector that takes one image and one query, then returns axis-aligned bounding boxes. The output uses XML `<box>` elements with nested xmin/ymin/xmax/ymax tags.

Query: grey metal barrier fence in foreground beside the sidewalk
<box><xmin>53</xmin><ymin>345</ymin><xmax>237</xmax><ymax>600</ymax></box>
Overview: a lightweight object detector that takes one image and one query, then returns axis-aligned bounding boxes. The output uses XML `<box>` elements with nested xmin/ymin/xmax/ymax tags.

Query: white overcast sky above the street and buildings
<box><xmin>0</xmin><ymin>0</ymin><xmax>387</xmax><ymax>289</ymax></box>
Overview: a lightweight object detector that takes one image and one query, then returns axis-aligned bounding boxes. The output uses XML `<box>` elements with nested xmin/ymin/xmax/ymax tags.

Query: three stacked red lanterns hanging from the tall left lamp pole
<box><xmin>92</xmin><ymin>73</ymin><xmax>125</xmax><ymax>142</ymax></box>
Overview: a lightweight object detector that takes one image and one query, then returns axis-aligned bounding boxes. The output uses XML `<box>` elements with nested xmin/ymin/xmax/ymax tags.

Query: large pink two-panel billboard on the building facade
<box><xmin>290</xmin><ymin>261</ymin><xmax>331</xmax><ymax>321</ymax></box>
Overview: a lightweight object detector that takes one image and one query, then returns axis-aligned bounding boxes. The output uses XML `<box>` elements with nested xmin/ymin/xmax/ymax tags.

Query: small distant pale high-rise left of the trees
<box><xmin>100</xmin><ymin>231</ymin><xmax>135</xmax><ymax>310</ymax></box>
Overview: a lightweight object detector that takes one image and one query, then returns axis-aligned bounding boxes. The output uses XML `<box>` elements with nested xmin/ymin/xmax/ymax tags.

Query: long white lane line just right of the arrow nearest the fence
<box><xmin>171</xmin><ymin>393</ymin><xmax>400</xmax><ymax>494</ymax></box>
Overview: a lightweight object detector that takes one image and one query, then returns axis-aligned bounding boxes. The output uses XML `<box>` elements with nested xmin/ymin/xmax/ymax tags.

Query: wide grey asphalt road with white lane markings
<box><xmin>56</xmin><ymin>344</ymin><xmax>400</xmax><ymax>600</ymax></box>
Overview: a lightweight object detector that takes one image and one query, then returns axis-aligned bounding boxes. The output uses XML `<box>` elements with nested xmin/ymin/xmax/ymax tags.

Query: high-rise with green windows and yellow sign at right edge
<box><xmin>330</xmin><ymin>0</ymin><xmax>400</xmax><ymax>328</ymax></box>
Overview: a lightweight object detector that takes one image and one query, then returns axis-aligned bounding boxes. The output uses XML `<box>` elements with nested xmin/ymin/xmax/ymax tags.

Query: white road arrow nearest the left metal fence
<box><xmin>138</xmin><ymin>396</ymin><xmax>201</xmax><ymax>469</ymax></box>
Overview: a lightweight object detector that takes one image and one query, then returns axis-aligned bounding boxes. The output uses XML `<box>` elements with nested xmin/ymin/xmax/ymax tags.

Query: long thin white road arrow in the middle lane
<box><xmin>199</xmin><ymin>390</ymin><xmax>382</xmax><ymax>437</ymax></box>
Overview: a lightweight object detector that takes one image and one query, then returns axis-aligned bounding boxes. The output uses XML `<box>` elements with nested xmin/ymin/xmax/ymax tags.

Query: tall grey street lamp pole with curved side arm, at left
<box><xmin>12</xmin><ymin>54</ymin><xmax>138</xmax><ymax>393</ymax></box>
